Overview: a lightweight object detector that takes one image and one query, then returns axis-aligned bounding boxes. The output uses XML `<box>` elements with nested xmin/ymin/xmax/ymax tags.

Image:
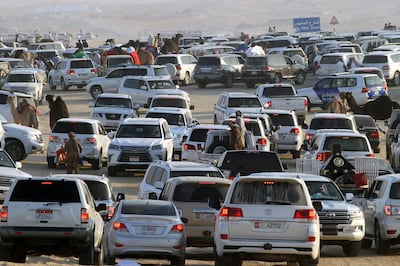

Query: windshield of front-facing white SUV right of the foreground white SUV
<box><xmin>306</xmin><ymin>181</ymin><xmax>344</xmax><ymax>201</ymax></box>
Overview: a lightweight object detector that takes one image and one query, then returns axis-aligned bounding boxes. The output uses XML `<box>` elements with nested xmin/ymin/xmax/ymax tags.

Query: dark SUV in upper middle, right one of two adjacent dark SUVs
<box><xmin>242</xmin><ymin>54</ymin><xmax>307</xmax><ymax>88</ymax></box>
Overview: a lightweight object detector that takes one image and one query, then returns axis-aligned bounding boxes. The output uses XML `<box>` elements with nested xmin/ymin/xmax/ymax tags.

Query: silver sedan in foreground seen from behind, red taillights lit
<box><xmin>103</xmin><ymin>200</ymin><xmax>187</xmax><ymax>266</ymax></box>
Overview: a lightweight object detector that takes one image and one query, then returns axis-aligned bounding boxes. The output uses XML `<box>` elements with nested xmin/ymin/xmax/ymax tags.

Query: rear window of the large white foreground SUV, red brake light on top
<box><xmin>230</xmin><ymin>179</ymin><xmax>307</xmax><ymax>206</ymax></box>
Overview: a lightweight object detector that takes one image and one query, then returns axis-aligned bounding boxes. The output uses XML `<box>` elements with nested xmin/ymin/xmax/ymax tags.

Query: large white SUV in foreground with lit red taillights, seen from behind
<box><xmin>214</xmin><ymin>172</ymin><xmax>320</xmax><ymax>265</ymax></box>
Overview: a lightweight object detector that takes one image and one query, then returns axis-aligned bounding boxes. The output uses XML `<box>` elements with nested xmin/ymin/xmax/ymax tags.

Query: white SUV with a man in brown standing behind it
<box><xmin>46</xmin><ymin>118</ymin><xmax>110</xmax><ymax>170</ymax></box>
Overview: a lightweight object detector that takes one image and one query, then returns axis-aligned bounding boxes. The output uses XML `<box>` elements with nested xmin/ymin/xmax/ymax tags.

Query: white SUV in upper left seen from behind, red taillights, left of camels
<box><xmin>48</xmin><ymin>58</ymin><xmax>97</xmax><ymax>90</ymax></box>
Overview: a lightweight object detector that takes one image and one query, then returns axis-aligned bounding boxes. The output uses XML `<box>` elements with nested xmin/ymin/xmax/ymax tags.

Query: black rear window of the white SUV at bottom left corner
<box><xmin>10</xmin><ymin>180</ymin><xmax>81</xmax><ymax>204</ymax></box>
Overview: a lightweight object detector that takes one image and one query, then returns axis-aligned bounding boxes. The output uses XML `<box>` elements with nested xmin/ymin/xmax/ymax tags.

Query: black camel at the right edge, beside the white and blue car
<box><xmin>340</xmin><ymin>92</ymin><xmax>399</xmax><ymax>120</ymax></box>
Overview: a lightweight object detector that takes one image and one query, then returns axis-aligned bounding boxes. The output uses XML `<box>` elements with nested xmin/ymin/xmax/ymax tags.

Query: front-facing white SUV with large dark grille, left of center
<box><xmin>107</xmin><ymin>118</ymin><xmax>174</xmax><ymax>176</ymax></box>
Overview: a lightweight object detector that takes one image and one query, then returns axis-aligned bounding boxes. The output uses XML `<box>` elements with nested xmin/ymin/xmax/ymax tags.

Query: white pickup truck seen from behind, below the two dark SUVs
<box><xmin>256</xmin><ymin>83</ymin><xmax>308</xmax><ymax>124</ymax></box>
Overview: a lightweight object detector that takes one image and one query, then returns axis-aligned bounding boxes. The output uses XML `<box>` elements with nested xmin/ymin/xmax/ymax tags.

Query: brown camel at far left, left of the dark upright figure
<box><xmin>7</xmin><ymin>97</ymin><xmax>39</xmax><ymax>128</ymax></box>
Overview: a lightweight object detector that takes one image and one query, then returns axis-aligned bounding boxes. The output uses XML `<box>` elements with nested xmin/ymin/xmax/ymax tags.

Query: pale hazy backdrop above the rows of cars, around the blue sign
<box><xmin>0</xmin><ymin>0</ymin><xmax>400</xmax><ymax>45</ymax></box>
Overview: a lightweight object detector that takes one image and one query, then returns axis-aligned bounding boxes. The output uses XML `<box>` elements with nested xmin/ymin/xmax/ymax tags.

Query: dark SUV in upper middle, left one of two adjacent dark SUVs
<box><xmin>194</xmin><ymin>54</ymin><xmax>245</xmax><ymax>89</ymax></box>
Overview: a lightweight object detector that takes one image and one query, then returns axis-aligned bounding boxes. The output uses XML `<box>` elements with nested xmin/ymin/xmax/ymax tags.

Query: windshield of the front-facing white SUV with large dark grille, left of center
<box><xmin>116</xmin><ymin>125</ymin><xmax>161</xmax><ymax>138</ymax></box>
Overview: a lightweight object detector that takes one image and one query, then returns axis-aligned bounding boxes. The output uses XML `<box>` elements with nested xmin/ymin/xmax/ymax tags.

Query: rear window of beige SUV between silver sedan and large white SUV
<box><xmin>173</xmin><ymin>182</ymin><xmax>230</xmax><ymax>202</ymax></box>
